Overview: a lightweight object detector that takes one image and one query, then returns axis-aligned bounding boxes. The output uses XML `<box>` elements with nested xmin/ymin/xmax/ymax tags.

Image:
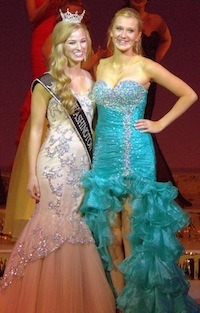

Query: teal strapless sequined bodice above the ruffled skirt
<box><xmin>93</xmin><ymin>80</ymin><xmax>155</xmax><ymax>178</ymax></box>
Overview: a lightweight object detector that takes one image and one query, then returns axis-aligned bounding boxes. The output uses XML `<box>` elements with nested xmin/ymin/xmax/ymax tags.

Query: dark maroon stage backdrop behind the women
<box><xmin>0</xmin><ymin>0</ymin><xmax>200</xmax><ymax>170</ymax></box>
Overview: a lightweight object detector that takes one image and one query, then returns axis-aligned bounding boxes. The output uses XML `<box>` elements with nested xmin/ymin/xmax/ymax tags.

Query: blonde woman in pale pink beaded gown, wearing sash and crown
<box><xmin>0</xmin><ymin>12</ymin><xmax>115</xmax><ymax>313</ymax></box>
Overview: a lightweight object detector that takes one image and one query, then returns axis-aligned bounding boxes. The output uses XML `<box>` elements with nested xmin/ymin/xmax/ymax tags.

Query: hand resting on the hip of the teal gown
<box><xmin>134</xmin><ymin>119</ymin><xmax>163</xmax><ymax>134</ymax></box>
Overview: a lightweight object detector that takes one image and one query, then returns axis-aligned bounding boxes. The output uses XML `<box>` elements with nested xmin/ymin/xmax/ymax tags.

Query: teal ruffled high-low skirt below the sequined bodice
<box><xmin>81</xmin><ymin>171</ymin><xmax>199</xmax><ymax>313</ymax></box>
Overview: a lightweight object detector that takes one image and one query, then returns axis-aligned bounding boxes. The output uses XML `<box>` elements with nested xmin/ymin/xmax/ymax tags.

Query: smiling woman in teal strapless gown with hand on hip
<box><xmin>81</xmin><ymin>8</ymin><xmax>198</xmax><ymax>313</ymax></box>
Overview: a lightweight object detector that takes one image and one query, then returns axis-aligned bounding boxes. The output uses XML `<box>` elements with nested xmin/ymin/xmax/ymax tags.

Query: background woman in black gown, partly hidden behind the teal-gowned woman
<box><xmin>127</xmin><ymin>0</ymin><xmax>192</xmax><ymax>207</ymax></box>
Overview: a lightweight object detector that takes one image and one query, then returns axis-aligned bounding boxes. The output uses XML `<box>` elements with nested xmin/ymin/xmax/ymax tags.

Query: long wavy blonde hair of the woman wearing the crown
<box><xmin>49</xmin><ymin>21</ymin><xmax>91</xmax><ymax>113</ymax></box>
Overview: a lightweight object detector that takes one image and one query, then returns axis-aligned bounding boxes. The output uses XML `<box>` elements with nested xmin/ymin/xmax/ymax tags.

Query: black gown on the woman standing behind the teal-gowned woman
<box><xmin>142</xmin><ymin>31</ymin><xmax>192</xmax><ymax>207</ymax></box>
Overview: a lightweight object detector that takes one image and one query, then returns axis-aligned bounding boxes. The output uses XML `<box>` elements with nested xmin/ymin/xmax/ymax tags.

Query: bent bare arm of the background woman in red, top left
<box><xmin>26</xmin><ymin>0</ymin><xmax>51</xmax><ymax>23</ymax></box>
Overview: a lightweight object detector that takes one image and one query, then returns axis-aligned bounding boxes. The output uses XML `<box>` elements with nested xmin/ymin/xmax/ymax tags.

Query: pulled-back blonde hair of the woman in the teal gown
<box><xmin>107</xmin><ymin>7</ymin><xmax>142</xmax><ymax>55</ymax></box>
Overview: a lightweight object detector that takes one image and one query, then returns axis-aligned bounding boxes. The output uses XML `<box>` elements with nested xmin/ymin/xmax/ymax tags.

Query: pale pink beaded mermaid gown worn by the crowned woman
<box><xmin>0</xmin><ymin>86</ymin><xmax>115</xmax><ymax>313</ymax></box>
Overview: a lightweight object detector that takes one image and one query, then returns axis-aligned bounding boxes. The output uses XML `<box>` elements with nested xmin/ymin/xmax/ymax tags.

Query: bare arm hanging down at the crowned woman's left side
<box><xmin>27</xmin><ymin>84</ymin><xmax>51</xmax><ymax>201</ymax></box>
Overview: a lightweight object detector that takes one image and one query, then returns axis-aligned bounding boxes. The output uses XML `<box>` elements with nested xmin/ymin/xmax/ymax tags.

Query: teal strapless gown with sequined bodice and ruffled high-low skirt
<box><xmin>80</xmin><ymin>80</ymin><xmax>198</xmax><ymax>313</ymax></box>
